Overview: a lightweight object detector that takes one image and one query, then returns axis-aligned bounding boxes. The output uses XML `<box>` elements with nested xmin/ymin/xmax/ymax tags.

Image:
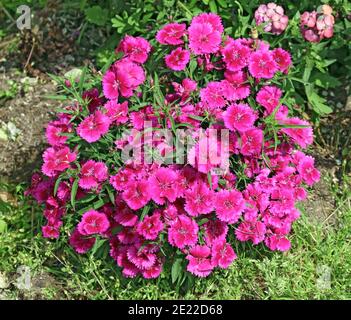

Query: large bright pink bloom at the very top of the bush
<box><xmin>188</xmin><ymin>15</ymin><xmax>223</xmax><ymax>54</ymax></box>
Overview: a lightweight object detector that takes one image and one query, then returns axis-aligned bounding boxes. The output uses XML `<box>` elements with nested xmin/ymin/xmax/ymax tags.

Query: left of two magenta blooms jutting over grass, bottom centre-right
<box><xmin>186</xmin><ymin>245</ymin><xmax>213</xmax><ymax>277</ymax></box>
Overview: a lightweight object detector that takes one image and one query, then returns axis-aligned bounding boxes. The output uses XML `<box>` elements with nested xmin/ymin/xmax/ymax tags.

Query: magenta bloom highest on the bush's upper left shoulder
<box><xmin>116</xmin><ymin>35</ymin><xmax>151</xmax><ymax>63</ymax></box>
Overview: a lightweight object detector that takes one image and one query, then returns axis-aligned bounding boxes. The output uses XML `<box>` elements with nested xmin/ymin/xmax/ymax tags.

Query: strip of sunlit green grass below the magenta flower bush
<box><xmin>0</xmin><ymin>180</ymin><xmax>351</xmax><ymax>299</ymax></box>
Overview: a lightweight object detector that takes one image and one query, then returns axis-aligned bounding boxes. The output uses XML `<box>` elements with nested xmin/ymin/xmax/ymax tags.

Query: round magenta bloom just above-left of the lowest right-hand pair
<box><xmin>168</xmin><ymin>215</ymin><xmax>199</xmax><ymax>249</ymax></box>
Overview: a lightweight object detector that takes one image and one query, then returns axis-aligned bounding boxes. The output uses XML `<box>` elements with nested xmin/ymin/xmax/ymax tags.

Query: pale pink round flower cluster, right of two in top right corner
<box><xmin>300</xmin><ymin>4</ymin><xmax>335</xmax><ymax>42</ymax></box>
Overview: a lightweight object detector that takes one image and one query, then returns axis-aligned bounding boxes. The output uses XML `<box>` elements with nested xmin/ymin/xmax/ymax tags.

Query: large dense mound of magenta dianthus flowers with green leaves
<box><xmin>27</xmin><ymin>11</ymin><xmax>320</xmax><ymax>278</ymax></box>
